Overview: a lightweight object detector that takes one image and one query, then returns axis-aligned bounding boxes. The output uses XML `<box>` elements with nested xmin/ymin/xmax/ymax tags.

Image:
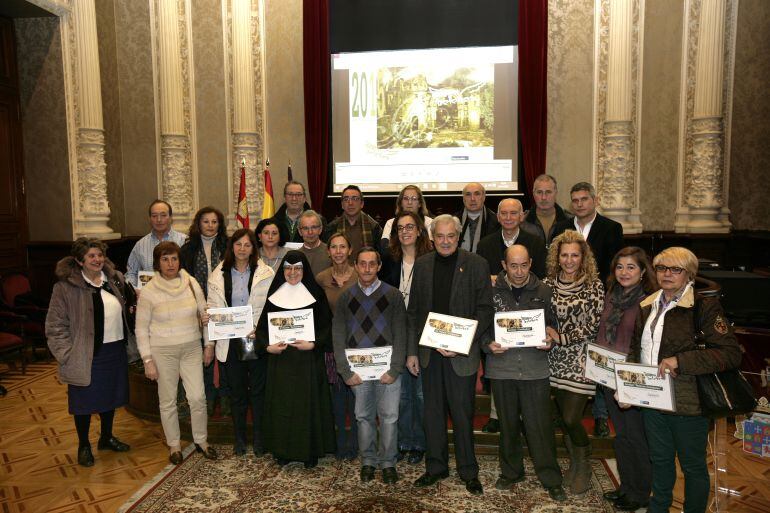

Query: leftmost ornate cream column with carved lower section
<box><xmin>69</xmin><ymin>0</ymin><xmax>120</xmax><ymax>239</ymax></box>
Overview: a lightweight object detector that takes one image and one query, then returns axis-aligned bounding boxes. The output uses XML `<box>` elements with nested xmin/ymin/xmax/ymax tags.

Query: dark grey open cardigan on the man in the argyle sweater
<box><xmin>332</xmin><ymin>282</ymin><xmax>406</xmax><ymax>380</ymax></box>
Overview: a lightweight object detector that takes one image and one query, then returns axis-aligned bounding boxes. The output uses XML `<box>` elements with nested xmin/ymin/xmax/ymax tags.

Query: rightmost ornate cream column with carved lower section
<box><xmin>674</xmin><ymin>0</ymin><xmax>737</xmax><ymax>233</ymax></box>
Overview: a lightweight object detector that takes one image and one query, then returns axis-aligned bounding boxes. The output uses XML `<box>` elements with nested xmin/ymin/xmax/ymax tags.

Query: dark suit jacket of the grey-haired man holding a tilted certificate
<box><xmin>406</xmin><ymin>249</ymin><xmax>494</xmax><ymax>376</ymax></box>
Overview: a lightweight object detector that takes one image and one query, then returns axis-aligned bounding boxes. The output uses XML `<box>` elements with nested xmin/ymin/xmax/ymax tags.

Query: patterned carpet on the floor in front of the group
<box><xmin>119</xmin><ymin>446</ymin><xmax>614</xmax><ymax>513</ymax></box>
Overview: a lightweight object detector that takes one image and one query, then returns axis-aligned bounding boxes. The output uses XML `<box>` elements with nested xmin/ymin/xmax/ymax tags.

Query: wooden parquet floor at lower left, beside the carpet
<box><xmin>0</xmin><ymin>363</ymin><xmax>168</xmax><ymax>513</ymax></box>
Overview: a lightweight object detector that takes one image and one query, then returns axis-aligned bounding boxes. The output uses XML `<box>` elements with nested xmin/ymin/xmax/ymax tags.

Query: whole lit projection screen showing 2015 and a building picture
<box><xmin>331</xmin><ymin>46</ymin><xmax>518</xmax><ymax>192</ymax></box>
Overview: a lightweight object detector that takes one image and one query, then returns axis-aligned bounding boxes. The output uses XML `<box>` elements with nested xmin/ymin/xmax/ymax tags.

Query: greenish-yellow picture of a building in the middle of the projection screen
<box><xmin>377</xmin><ymin>65</ymin><xmax>495</xmax><ymax>149</ymax></box>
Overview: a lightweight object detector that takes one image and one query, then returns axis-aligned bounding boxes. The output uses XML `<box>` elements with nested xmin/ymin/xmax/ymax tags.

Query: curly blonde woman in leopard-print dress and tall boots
<box><xmin>544</xmin><ymin>230</ymin><xmax>604</xmax><ymax>494</ymax></box>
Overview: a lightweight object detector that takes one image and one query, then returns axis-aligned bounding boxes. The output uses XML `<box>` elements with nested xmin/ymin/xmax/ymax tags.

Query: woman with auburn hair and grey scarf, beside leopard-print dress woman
<box><xmin>596</xmin><ymin>246</ymin><xmax>658</xmax><ymax>511</ymax></box>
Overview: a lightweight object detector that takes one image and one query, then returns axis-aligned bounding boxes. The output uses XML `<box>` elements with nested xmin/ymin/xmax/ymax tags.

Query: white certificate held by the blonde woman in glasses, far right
<box><xmin>615</xmin><ymin>362</ymin><xmax>676</xmax><ymax>411</ymax></box>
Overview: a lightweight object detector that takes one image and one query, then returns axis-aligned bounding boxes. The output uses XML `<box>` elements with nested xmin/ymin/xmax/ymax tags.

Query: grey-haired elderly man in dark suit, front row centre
<box><xmin>407</xmin><ymin>215</ymin><xmax>494</xmax><ymax>495</ymax></box>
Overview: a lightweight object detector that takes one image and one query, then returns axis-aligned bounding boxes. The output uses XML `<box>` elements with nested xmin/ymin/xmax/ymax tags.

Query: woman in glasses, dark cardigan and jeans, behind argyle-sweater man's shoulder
<box><xmin>380</xmin><ymin>211</ymin><xmax>433</xmax><ymax>464</ymax></box>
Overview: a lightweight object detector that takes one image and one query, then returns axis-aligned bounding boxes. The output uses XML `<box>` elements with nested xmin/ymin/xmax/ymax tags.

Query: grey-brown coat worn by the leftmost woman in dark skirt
<box><xmin>45</xmin><ymin>257</ymin><xmax>129</xmax><ymax>386</ymax></box>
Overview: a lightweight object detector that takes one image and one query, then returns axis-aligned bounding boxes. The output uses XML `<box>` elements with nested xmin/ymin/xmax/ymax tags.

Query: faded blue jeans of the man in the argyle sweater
<box><xmin>351</xmin><ymin>376</ymin><xmax>401</xmax><ymax>468</ymax></box>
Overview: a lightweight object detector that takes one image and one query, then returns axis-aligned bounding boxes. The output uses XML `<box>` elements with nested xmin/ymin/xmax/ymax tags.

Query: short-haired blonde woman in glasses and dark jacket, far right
<box><xmin>629</xmin><ymin>247</ymin><xmax>741</xmax><ymax>513</ymax></box>
